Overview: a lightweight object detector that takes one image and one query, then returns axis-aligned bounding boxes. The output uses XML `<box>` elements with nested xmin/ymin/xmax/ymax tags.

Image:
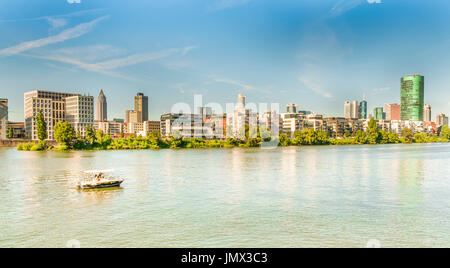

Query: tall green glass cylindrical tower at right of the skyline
<box><xmin>401</xmin><ymin>75</ymin><xmax>425</xmax><ymax>121</ymax></box>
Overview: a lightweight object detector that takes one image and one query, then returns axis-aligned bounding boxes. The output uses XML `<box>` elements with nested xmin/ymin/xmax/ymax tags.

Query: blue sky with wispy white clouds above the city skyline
<box><xmin>0</xmin><ymin>0</ymin><xmax>450</xmax><ymax>121</ymax></box>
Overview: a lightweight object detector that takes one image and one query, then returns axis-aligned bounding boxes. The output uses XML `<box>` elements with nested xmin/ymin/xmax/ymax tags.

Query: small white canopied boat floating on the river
<box><xmin>78</xmin><ymin>170</ymin><xmax>123</xmax><ymax>189</ymax></box>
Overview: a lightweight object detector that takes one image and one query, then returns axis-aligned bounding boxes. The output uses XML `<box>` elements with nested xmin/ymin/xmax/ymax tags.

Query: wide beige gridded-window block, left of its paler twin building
<box><xmin>24</xmin><ymin>90</ymin><xmax>81</xmax><ymax>140</ymax></box>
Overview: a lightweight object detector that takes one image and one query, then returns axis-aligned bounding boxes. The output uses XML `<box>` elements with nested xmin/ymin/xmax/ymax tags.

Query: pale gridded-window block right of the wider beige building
<box><xmin>65</xmin><ymin>95</ymin><xmax>94</xmax><ymax>137</ymax></box>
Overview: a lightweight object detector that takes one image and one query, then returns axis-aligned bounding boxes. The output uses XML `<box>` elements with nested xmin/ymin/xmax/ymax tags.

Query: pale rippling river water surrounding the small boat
<box><xmin>0</xmin><ymin>144</ymin><xmax>450</xmax><ymax>247</ymax></box>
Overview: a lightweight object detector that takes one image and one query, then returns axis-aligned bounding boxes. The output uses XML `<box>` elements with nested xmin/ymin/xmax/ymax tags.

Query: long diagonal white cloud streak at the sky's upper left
<box><xmin>0</xmin><ymin>16</ymin><xmax>108</xmax><ymax>56</ymax></box>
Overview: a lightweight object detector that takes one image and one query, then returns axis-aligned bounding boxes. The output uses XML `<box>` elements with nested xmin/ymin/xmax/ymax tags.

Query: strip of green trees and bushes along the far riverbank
<box><xmin>17</xmin><ymin>116</ymin><xmax>450</xmax><ymax>151</ymax></box>
